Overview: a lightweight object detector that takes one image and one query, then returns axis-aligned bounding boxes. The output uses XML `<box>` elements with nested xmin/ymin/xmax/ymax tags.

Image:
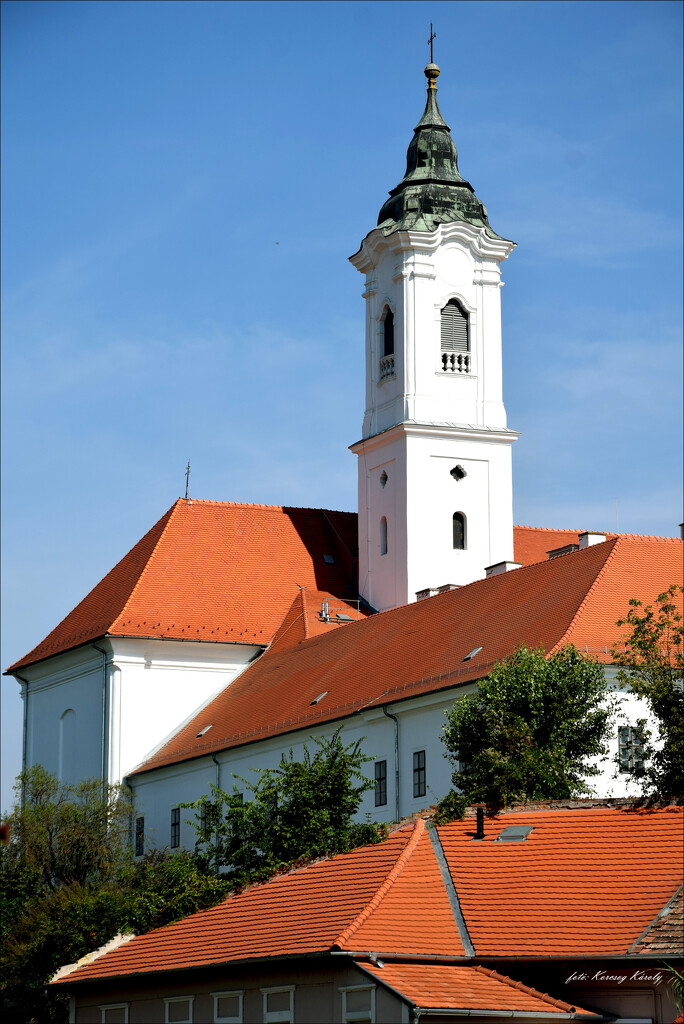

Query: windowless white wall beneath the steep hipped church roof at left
<box><xmin>19</xmin><ymin>637</ymin><xmax>263</xmax><ymax>782</ymax></box>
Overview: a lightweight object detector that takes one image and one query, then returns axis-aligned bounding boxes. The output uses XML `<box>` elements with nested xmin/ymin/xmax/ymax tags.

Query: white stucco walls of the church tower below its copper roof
<box><xmin>352</xmin><ymin>223</ymin><xmax>518</xmax><ymax>609</ymax></box>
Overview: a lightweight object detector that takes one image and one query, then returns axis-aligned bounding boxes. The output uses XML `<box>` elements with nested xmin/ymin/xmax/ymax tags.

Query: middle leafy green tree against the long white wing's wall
<box><xmin>184</xmin><ymin>729</ymin><xmax>381</xmax><ymax>885</ymax></box>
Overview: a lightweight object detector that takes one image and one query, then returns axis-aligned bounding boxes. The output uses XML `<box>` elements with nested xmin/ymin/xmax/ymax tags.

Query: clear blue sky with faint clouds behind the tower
<box><xmin>2</xmin><ymin>0</ymin><xmax>682</xmax><ymax>807</ymax></box>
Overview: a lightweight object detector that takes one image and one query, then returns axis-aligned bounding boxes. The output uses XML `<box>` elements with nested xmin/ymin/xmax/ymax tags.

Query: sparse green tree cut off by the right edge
<box><xmin>612</xmin><ymin>584</ymin><xmax>684</xmax><ymax>800</ymax></box>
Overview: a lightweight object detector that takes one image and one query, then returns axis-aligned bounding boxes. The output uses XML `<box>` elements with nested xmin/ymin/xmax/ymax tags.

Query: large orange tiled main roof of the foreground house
<box><xmin>55</xmin><ymin>807</ymin><xmax>683</xmax><ymax>987</ymax></box>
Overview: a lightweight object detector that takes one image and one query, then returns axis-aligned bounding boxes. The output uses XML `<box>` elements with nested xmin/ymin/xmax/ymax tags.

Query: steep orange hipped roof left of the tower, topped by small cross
<box><xmin>8</xmin><ymin>499</ymin><xmax>356</xmax><ymax>672</ymax></box>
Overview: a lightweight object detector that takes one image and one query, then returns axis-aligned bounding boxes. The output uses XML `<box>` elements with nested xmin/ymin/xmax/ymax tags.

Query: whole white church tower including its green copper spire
<box><xmin>351</xmin><ymin>63</ymin><xmax>518</xmax><ymax>609</ymax></box>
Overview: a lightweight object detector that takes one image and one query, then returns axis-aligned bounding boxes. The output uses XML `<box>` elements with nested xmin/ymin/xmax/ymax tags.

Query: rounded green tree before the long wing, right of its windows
<box><xmin>442</xmin><ymin>645</ymin><xmax>614</xmax><ymax>814</ymax></box>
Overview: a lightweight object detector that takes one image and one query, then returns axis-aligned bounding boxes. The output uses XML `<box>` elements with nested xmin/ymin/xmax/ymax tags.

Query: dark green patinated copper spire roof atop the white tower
<box><xmin>378</xmin><ymin>63</ymin><xmax>501</xmax><ymax>239</ymax></box>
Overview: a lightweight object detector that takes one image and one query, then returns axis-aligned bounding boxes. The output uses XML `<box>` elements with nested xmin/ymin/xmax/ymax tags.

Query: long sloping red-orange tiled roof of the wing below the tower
<box><xmin>136</xmin><ymin>537</ymin><xmax>682</xmax><ymax>771</ymax></box>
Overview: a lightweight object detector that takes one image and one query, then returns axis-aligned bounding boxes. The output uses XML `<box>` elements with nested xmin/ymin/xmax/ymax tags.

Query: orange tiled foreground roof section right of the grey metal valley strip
<box><xmin>438</xmin><ymin>807</ymin><xmax>683</xmax><ymax>956</ymax></box>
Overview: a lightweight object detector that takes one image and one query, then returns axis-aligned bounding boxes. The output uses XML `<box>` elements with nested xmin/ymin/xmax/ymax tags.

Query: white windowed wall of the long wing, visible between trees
<box><xmin>128</xmin><ymin>671</ymin><xmax>649</xmax><ymax>849</ymax></box>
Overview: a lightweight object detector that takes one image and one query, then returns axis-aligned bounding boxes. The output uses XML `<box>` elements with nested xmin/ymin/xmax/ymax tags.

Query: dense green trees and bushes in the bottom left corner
<box><xmin>0</xmin><ymin>767</ymin><xmax>230</xmax><ymax>1024</ymax></box>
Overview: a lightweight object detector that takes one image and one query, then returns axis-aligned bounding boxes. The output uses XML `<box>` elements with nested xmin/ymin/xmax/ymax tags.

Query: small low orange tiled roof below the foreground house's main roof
<box><xmin>357</xmin><ymin>961</ymin><xmax>603</xmax><ymax>1020</ymax></box>
